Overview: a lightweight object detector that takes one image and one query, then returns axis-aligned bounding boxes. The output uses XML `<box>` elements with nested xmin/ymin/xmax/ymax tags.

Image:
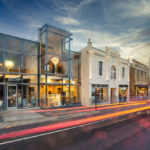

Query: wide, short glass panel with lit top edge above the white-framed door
<box><xmin>5</xmin><ymin>75</ymin><xmax>22</xmax><ymax>83</ymax></box>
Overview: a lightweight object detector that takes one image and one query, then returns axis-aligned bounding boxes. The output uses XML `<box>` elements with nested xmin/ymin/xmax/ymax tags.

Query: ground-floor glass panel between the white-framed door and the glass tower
<box><xmin>23</xmin><ymin>85</ymin><xmax>37</xmax><ymax>107</ymax></box>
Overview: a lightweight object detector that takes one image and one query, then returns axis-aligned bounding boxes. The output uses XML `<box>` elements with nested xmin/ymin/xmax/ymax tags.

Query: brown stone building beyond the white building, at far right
<box><xmin>130</xmin><ymin>60</ymin><xmax>148</xmax><ymax>99</ymax></box>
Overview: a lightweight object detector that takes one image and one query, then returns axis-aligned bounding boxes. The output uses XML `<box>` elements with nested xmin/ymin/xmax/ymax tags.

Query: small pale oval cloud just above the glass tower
<box><xmin>55</xmin><ymin>17</ymin><xmax>80</xmax><ymax>25</ymax></box>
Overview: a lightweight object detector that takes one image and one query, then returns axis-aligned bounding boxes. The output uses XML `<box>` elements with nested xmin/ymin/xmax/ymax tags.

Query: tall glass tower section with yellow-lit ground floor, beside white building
<box><xmin>40</xmin><ymin>25</ymin><xmax>80</xmax><ymax>107</ymax></box>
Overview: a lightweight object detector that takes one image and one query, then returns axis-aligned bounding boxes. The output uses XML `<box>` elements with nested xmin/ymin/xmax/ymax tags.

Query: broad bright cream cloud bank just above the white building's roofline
<box><xmin>70</xmin><ymin>28</ymin><xmax>150</xmax><ymax>65</ymax></box>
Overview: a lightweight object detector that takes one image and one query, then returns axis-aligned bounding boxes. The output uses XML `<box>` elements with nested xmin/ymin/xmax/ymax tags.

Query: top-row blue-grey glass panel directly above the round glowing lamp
<box><xmin>5</xmin><ymin>37</ymin><xmax>22</xmax><ymax>51</ymax></box>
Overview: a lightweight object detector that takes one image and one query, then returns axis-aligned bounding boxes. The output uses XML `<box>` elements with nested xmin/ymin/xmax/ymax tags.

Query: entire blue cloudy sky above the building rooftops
<box><xmin>0</xmin><ymin>0</ymin><xmax>150</xmax><ymax>65</ymax></box>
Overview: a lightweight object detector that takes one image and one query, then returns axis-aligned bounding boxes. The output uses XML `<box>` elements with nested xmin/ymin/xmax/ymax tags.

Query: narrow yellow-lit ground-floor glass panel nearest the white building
<box><xmin>70</xmin><ymin>86</ymin><xmax>78</xmax><ymax>103</ymax></box>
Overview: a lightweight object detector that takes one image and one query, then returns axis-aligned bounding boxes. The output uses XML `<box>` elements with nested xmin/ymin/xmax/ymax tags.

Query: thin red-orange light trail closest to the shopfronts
<box><xmin>26</xmin><ymin>101</ymin><xmax>143</xmax><ymax>113</ymax></box>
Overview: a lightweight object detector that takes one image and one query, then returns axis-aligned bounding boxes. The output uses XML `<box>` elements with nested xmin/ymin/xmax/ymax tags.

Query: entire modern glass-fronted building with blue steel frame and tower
<box><xmin>0</xmin><ymin>24</ymin><xmax>80</xmax><ymax>109</ymax></box>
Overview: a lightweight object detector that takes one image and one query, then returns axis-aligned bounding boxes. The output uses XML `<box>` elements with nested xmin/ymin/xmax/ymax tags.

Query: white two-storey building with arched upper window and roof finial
<box><xmin>81</xmin><ymin>40</ymin><xmax>130</xmax><ymax>106</ymax></box>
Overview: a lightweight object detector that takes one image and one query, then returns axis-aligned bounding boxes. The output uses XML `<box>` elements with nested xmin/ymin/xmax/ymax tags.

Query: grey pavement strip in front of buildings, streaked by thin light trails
<box><xmin>0</xmin><ymin>102</ymin><xmax>149</xmax><ymax>129</ymax></box>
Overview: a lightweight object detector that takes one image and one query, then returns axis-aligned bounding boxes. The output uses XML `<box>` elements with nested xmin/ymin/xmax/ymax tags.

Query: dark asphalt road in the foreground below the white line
<box><xmin>0</xmin><ymin>113</ymin><xmax>150</xmax><ymax>150</ymax></box>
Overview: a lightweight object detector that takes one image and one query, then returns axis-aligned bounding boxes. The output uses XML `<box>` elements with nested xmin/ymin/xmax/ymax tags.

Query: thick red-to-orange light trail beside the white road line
<box><xmin>0</xmin><ymin>106</ymin><xmax>150</xmax><ymax>140</ymax></box>
